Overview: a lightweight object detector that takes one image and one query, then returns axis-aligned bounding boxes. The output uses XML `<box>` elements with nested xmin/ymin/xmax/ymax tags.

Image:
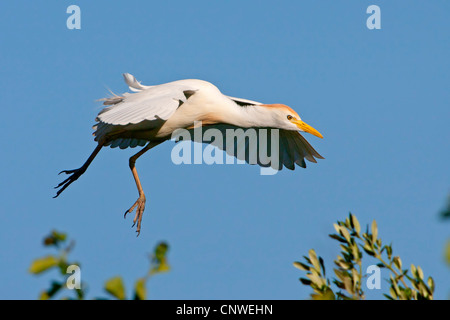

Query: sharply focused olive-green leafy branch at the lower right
<box><xmin>294</xmin><ymin>213</ymin><xmax>434</xmax><ymax>300</ymax></box>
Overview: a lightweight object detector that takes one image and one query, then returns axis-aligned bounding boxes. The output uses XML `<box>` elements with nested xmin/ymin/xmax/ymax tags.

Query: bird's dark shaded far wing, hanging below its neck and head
<box><xmin>176</xmin><ymin>124</ymin><xmax>324</xmax><ymax>170</ymax></box>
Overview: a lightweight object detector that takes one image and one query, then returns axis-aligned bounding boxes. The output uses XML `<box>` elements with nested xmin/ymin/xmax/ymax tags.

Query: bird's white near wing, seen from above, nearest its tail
<box><xmin>96</xmin><ymin>73</ymin><xmax>196</xmax><ymax>125</ymax></box>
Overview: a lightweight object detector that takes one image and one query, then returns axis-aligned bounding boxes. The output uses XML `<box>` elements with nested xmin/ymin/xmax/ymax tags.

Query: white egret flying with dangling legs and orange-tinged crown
<box><xmin>54</xmin><ymin>73</ymin><xmax>323</xmax><ymax>235</ymax></box>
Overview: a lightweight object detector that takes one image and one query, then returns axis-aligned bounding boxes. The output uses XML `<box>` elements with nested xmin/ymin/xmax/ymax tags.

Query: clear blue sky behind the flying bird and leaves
<box><xmin>0</xmin><ymin>0</ymin><xmax>450</xmax><ymax>299</ymax></box>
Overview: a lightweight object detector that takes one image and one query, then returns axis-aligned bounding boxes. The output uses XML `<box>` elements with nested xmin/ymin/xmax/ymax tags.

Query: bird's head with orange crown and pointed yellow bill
<box><xmin>262</xmin><ymin>104</ymin><xmax>323</xmax><ymax>138</ymax></box>
